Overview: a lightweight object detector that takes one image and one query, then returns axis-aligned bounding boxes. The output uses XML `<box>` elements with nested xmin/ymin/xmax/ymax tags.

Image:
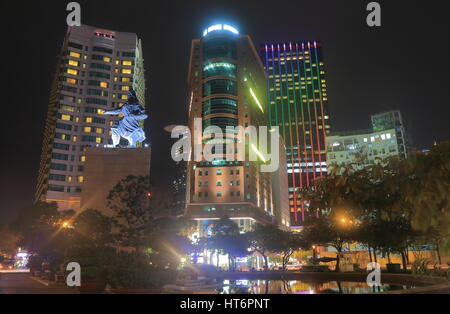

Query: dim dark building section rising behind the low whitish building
<box><xmin>371</xmin><ymin>110</ymin><xmax>409</xmax><ymax>158</ymax></box>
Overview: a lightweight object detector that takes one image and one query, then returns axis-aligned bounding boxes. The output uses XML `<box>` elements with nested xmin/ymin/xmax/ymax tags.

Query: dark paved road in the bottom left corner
<box><xmin>0</xmin><ymin>273</ymin><xmax>79</xmax><ymax>294</ymax></box>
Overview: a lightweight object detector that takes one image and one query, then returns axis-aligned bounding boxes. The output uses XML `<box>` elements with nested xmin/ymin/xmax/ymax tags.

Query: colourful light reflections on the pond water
<box><xmin>219</xmin><ymin>280</ymin><xmax>413</xmax><ymax>294</ymax></box>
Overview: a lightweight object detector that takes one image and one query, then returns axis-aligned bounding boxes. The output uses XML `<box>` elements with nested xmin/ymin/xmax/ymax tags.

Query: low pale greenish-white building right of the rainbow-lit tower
<box><xmin>327</xmin><ymin>129</ymin><xmax>401</xmax><ymax>170</ymax></box>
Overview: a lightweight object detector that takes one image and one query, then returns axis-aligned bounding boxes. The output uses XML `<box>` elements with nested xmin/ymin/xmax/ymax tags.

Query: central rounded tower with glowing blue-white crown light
<box><xmin>186</xmin><ymin>24</ymin><xmax>274</xmax><ymax>236</ymax></box>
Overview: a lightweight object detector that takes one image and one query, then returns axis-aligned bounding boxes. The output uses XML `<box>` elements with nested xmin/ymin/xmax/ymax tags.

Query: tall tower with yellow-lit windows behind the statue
<box><xmin>35</xmin><ymin>25</ymin><xmax>145</xmax><ymax>210</ymax></box>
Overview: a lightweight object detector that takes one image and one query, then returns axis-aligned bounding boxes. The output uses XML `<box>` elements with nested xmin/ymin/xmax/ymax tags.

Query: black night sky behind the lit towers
<box><xmin>0</xmin><ymin>0</ymin><xmax>450</xmax><ymax>223</ymax></box>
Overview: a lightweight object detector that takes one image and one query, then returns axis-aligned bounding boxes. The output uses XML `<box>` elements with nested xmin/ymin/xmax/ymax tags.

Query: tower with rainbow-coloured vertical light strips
<box><xmin>261</xmin><ymin>41</ymin><xmax>330</xmax><ymax>225</ymax></box>
